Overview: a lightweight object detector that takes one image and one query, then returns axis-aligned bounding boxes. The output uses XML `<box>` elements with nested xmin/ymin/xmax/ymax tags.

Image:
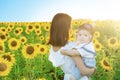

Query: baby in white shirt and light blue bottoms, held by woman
<box><xmin>61</xmin><ymin>23</ymin><xmax>96</xmax><ymax>80</ymax></box>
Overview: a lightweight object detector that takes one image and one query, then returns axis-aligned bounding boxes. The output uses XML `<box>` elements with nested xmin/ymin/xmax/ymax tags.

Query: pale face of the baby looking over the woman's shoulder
<box><xmin>77</xmin><ymin>29</ymin><xmax>92</xmax><ymax>43</ymax></box>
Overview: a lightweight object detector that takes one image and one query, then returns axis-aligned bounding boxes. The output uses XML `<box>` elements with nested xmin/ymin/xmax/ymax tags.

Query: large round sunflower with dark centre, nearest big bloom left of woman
<box><xmin>22</xmin><ymin>45</ymin><xmax>37</xmax><ymax>59</ymax></box>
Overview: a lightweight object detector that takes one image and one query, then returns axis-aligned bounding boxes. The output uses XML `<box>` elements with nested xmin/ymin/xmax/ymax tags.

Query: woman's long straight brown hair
<box><xmin>48</xmin><ymin>13</ymin><xmax>72</xmax><ymax>47</ymax></box>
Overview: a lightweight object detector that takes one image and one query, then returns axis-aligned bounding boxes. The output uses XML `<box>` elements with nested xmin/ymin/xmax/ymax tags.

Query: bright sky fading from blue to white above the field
<box><xmin>0</xmin><ymin>0</ymin><xmax>120</xmax><ymax>22</ymax></box>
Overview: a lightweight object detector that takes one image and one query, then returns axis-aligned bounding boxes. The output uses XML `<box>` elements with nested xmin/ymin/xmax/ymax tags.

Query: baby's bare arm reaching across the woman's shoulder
<box><xmin>61</xmin><ymin>49</ymin><xmax>80</xmax><ymax>56</ymax></box>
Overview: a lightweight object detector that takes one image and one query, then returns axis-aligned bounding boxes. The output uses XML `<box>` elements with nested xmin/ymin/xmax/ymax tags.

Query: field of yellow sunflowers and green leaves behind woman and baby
<box><xmin>0</xmin><ymin>19</ymin><xmax>120</xmax><ymax>80</ymax></box>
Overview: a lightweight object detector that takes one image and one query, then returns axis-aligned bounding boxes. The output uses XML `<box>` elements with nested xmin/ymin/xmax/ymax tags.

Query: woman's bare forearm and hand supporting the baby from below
<box><xmin>72</xmin><ymin>56</ymin><xmax>95</xmax><ymax>76</ymax></box>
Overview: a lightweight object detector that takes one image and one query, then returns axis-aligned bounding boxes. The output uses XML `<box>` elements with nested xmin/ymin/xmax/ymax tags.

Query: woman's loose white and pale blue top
<box><xmin>49</xmin><ymin>42</ymin><xmax>82</xmax><ymax>80</ymax></box>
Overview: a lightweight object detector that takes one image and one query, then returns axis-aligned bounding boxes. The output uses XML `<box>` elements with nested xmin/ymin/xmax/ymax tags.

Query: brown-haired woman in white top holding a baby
<box><xmin>48</xmin><ymin>13</ymin><xmax>95</xmax><ymax>80</ymax></box>
